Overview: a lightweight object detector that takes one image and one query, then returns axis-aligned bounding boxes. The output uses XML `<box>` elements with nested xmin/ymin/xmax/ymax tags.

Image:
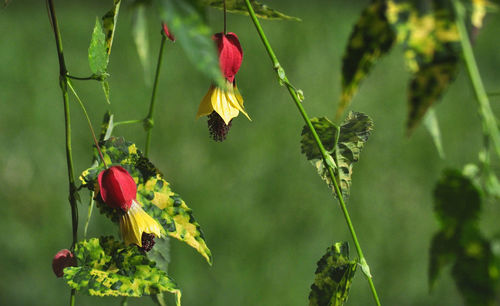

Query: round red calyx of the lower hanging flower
<box><xmin>97</xmin><ymin>166</ymin><xmax>137</xmax><ymax>211</ymax></box>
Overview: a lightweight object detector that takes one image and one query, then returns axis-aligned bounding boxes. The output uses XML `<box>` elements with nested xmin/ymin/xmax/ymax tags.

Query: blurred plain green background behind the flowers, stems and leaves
<box><xmin>0</xmin><ymin>0</ymin><xmax>500</xmax><ymax>305</ymax></box>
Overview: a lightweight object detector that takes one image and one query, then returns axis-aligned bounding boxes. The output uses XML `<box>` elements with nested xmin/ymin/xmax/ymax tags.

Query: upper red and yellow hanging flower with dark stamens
<box><xmin>196</xmin><ymin>33</ymin><xmax>251</xmax><ymax>141</ymax></box>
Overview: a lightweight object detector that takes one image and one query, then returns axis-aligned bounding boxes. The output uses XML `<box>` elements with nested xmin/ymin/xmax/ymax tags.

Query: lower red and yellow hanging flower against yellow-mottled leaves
<box><xmin>98</xmin><ymin>166</ymin><xmax>164</xmax><ymax>251</ymax></box>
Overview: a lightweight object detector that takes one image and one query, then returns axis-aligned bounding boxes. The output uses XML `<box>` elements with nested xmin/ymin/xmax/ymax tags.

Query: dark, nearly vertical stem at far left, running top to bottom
<box><xmin>47</xmin><ymin>0</ymin><xmax>78</xmax><ymax>305</ymax></box>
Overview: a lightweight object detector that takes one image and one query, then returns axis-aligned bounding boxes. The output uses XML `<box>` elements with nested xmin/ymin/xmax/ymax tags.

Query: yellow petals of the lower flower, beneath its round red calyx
<box><xmin>120</xmin><ymin>201</ymin><xmax>165</xmax><ymax>247</ymax></box>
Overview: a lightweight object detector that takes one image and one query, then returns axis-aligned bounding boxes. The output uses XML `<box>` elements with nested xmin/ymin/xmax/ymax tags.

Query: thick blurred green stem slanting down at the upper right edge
<box><xmin>453</xmin><ymin>0</ymin><xmax>500</xmax><ymax>157</ymax></box>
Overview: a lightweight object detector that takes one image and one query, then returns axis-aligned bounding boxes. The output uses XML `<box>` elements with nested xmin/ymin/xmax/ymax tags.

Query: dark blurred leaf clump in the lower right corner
<box><xmin>429</xmin><ymin>170</ymin><xmax>500</xmax><ymax>305</ymax></box>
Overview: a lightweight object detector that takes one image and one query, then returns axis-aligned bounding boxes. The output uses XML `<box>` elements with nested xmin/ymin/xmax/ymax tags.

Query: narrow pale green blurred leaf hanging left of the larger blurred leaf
<box><xmin>132</xmin><ymin>2</ymin><xmax>151</xmax><ymax>84</ymax></box>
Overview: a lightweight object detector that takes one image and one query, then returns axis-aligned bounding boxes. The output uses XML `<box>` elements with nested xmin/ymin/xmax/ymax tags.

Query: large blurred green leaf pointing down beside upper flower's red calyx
<box><xmin>157</xmin><ymin>0</ymin><xmax>225</xmax><ymax>87</ymax></box>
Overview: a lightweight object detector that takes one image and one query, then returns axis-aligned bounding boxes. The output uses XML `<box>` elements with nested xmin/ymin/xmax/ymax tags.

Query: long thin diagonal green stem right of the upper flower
<box><xmin>245</xmin><ymin>0</ymin><xmax>380</xmax><ymax>305</ymax></box>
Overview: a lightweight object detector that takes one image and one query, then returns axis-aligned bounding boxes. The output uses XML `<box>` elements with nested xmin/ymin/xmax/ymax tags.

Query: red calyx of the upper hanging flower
<box><xmin>212</xmin><ymin>32</ymin><xmax>243</xmax><ymax>82</ymax></box>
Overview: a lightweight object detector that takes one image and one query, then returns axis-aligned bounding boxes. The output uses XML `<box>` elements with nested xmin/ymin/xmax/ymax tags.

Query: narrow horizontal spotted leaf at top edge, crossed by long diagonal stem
<box><xmin>202</xmin><ymin>0</ymin><xmax>301</xmax><ymax>21</ymax></box>
